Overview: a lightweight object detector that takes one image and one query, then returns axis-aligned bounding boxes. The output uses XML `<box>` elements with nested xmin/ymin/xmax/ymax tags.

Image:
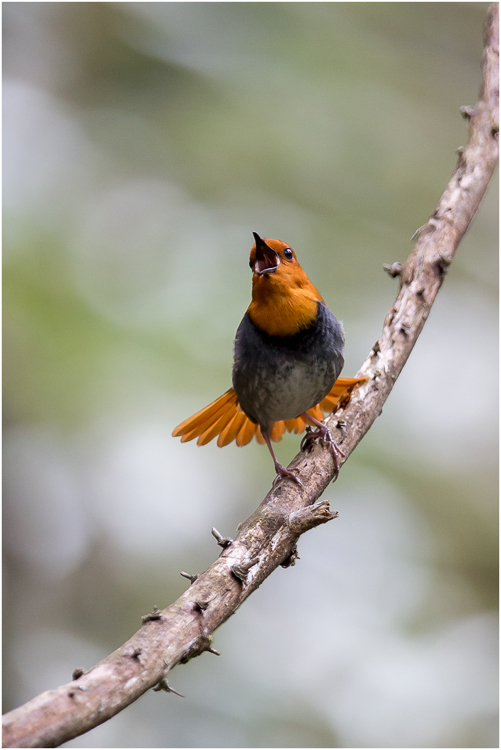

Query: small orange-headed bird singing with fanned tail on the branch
<box><xmin>172</xmin><ymin>232</ymin><xmax>366</xmax><ymax>486</ymax></box>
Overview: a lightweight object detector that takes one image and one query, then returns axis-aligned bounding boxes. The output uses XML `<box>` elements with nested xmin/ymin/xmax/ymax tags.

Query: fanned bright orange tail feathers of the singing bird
<box><xmin>172</xmin><ymin>378</ymin><xmax>367</xmax><ymax>448</ymax></box>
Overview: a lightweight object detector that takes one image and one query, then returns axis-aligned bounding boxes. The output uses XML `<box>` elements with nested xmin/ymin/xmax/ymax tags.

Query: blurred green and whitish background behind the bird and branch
<box><xmin>3</xmin><ymin>2</ymin><xmax>498</xmax><ymax>747</ymax></box>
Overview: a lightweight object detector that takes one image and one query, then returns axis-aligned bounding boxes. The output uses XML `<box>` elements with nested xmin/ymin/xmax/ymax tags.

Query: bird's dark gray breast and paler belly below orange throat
<box><xmin>233</xmin><ymin>302</ymin><xmax>344</xmax><ymax>429</ymax></box>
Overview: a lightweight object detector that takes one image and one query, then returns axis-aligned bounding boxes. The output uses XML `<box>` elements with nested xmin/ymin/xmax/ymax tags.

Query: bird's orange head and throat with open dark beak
<box><xmin>248</xmin><ymin>232</ymin><xmax>323</xmax><ymax>336</ymax></box>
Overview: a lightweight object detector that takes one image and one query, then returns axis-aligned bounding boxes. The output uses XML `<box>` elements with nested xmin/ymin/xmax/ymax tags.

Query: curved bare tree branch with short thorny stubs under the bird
<box><xmin>3</xmin><ymin>4</ymin><xmax>499</xmax><ymax>747</ymax></box>
